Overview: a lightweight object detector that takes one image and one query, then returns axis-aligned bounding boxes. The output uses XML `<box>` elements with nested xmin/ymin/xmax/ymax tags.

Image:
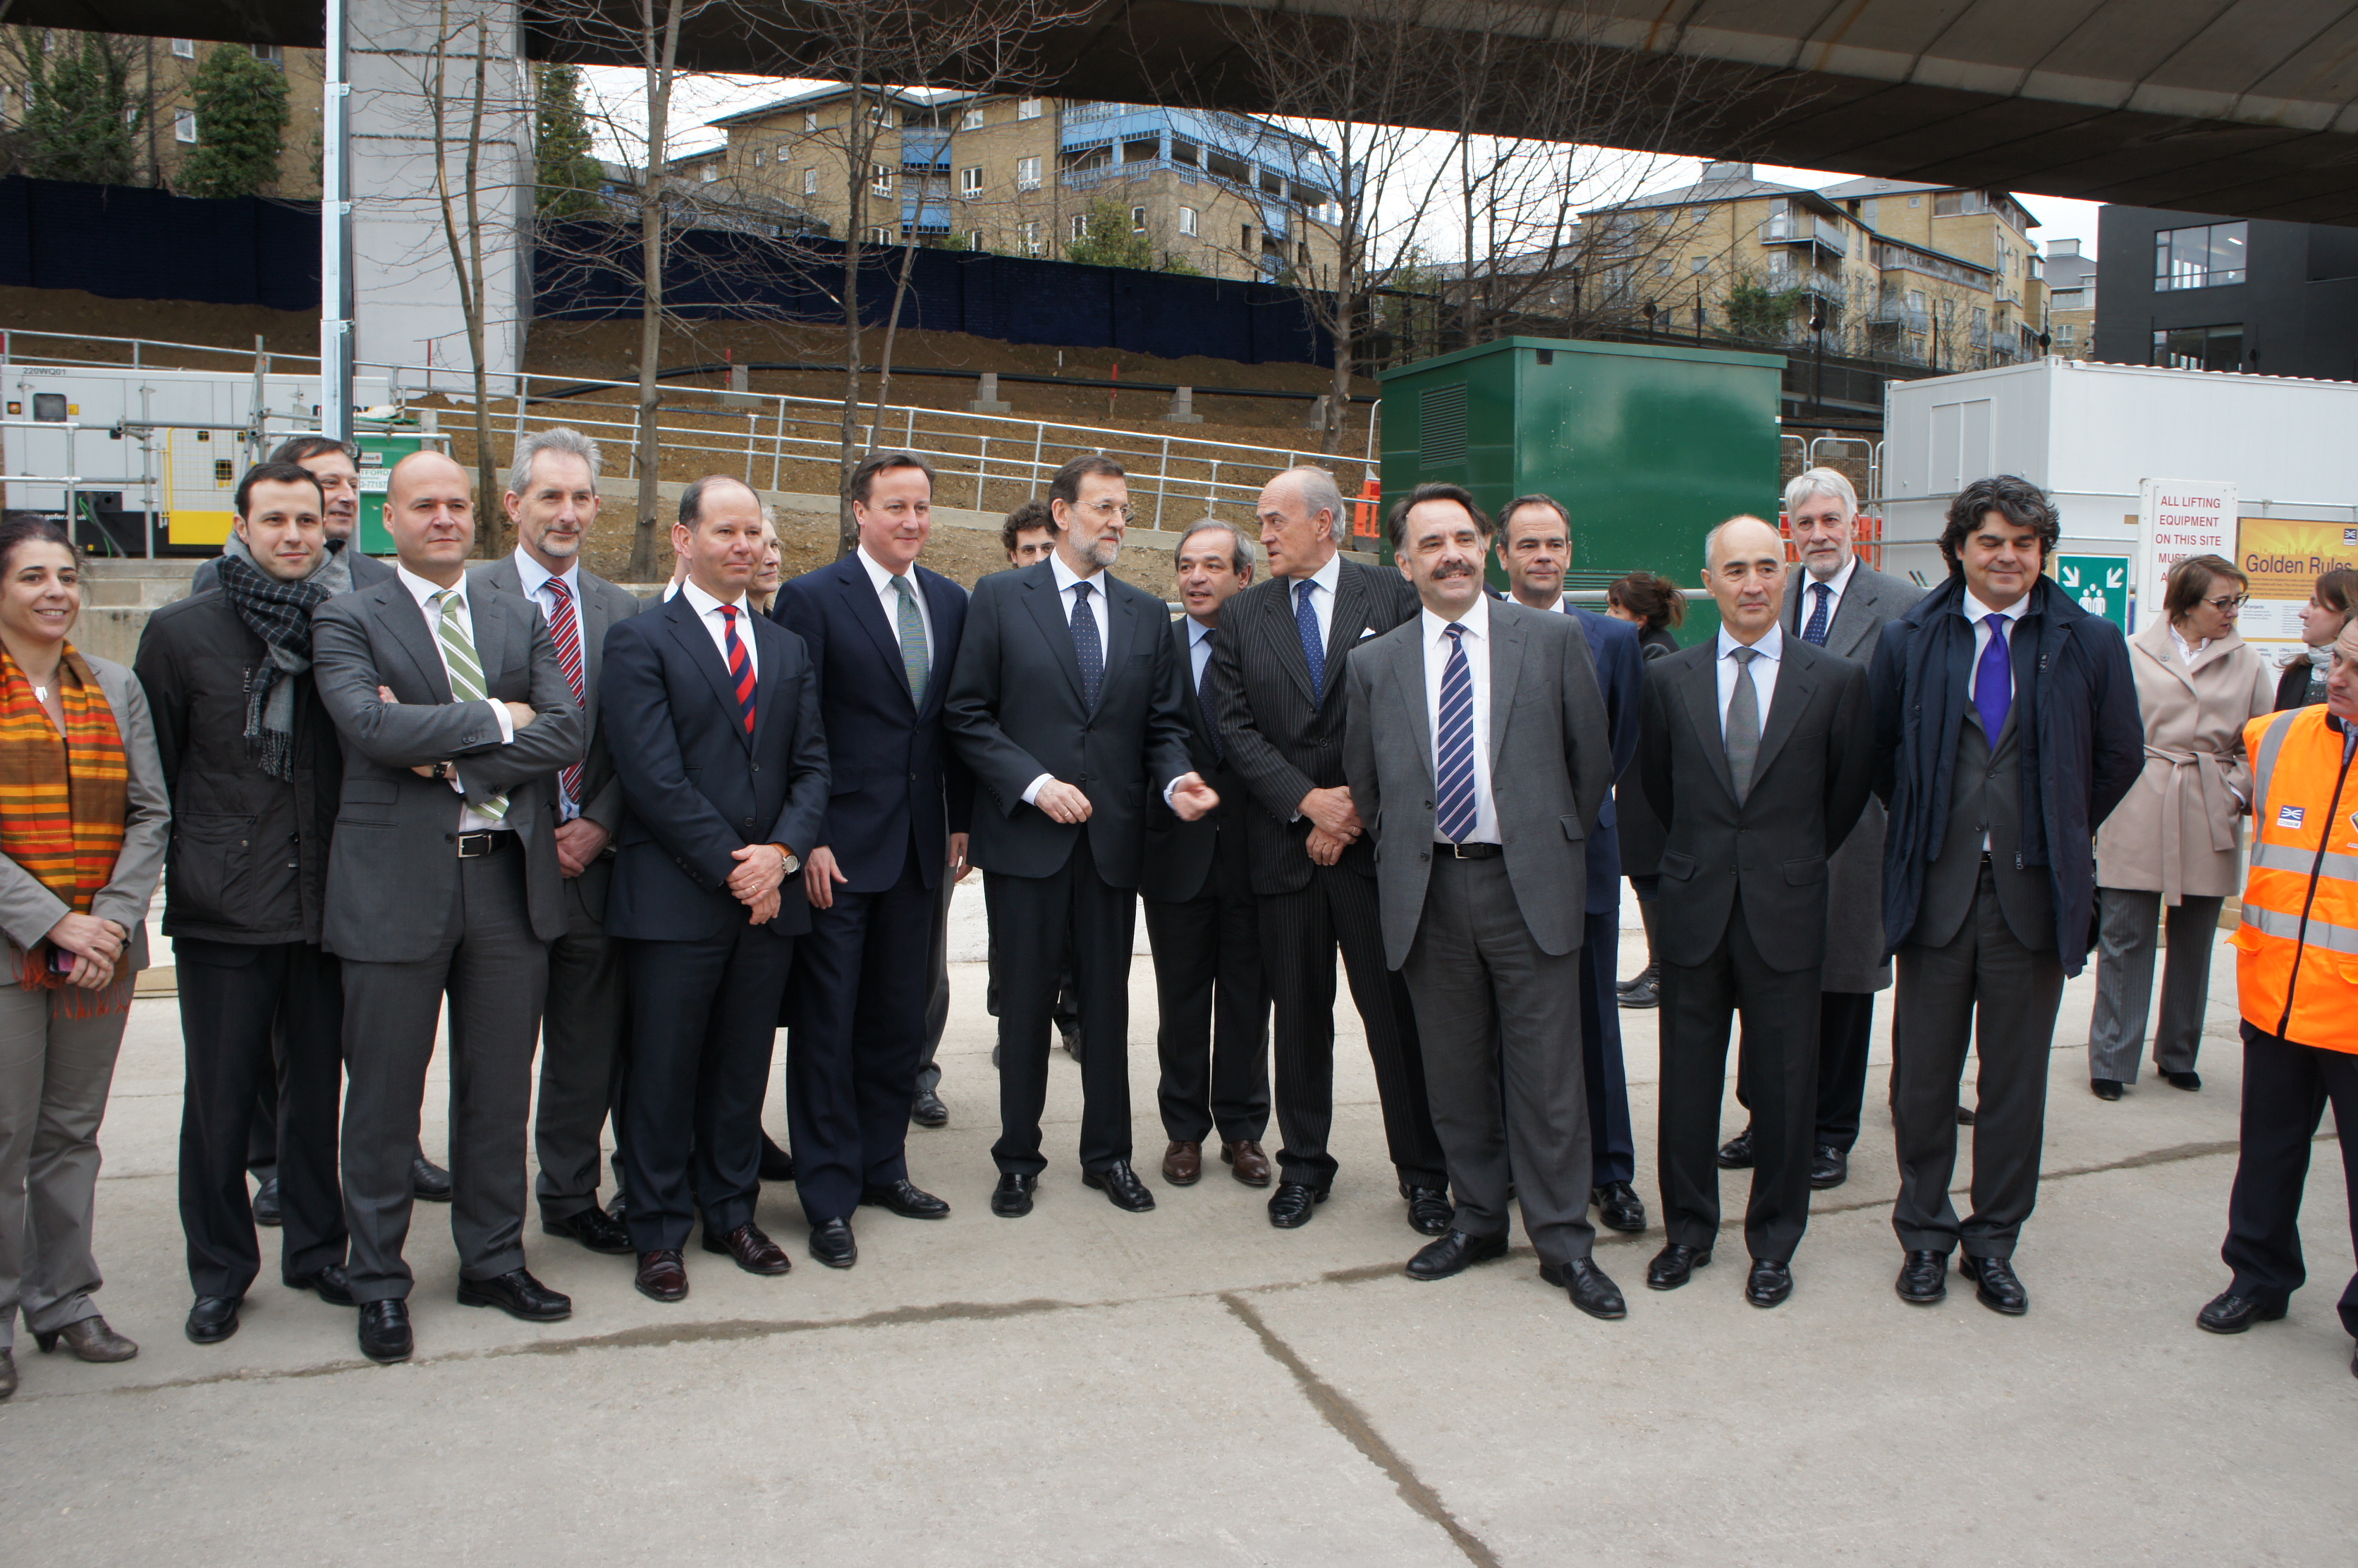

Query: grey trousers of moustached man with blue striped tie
<box><xmin>1400</xmin><ymin>854</ymin><xmax>1596</xmax><ymax>1264</ymax></box>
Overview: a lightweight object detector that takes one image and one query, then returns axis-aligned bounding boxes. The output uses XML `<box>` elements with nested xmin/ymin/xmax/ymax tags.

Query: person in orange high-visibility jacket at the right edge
<box><xmin>2195</xmin><ymin>625</ymin><xmax>2358</xmax><ymax>1377</ymax></box>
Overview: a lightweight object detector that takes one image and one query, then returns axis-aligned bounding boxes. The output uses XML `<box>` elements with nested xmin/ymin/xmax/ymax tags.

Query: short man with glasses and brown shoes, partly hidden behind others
<box><xmin>1139</xmin><ymin>516</ymin><xmax>1269</xmax><ymax>1186</ymax></box>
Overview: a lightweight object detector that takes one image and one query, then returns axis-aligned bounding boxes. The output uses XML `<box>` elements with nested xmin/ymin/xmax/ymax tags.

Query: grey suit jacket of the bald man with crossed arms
<box><xmin>311</xmin><ymin>577</ymin><xmax>582</xmax><ymax>964</ymax></box>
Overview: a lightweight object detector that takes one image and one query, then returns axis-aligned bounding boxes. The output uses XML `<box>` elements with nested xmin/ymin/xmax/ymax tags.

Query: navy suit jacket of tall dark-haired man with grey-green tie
<box><xmin>769</xmin><ymin>554</ymin><xmax>974</xmax><ymax>894</ymax></box>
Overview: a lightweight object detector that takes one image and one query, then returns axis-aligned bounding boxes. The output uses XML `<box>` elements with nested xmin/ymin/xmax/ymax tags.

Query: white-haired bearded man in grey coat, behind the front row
<box><xmin>1719</xmin><ymin>470</ymin><xmax>1924</xmax><ymax>1191</ymax></box>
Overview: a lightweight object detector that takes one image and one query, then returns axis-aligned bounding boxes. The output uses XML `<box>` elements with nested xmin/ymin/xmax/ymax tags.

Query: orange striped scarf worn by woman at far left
<box><xmin>0</xmin><ymin>644</ymin><xmax>130</xmax><ymax>995</ymax></box>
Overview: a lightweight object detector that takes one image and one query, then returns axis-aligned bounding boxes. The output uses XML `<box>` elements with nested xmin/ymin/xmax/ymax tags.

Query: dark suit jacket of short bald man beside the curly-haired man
<box><xmin>1637</xmin><ymin>637</ymin><xmax>1874</xmax><ymax>974</ymax></box>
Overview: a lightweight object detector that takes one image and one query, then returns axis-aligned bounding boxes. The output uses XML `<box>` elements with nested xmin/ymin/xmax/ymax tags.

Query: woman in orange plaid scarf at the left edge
<box><xmin>0</xmin><ymin>514</ymin><xmax>172</xmax><ymax>1398</ymax></box>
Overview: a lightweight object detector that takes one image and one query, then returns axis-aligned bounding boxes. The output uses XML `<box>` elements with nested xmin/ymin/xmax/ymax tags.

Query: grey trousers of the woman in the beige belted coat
<box><xmin>2087</xmin><ymin>886</ymin><xmax>2226</xmax><ymax>1082</ymax></box>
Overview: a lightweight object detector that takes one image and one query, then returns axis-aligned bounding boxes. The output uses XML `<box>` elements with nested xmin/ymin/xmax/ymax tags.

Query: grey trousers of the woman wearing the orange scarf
<box><xmin>0</xmin><ymin>981</ymin><xmax>130</xmax><ymax>1351</ymax></box>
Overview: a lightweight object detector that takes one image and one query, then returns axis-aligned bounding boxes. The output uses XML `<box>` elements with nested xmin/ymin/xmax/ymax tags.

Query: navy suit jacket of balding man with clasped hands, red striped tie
<box><xmin>599</xmin><ymin>594</ymin><xmax>828</xmax><ymax>941</ymax></box>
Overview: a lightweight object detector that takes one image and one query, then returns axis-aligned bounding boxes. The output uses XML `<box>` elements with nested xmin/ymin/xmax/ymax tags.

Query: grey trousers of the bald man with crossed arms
<box><xmin>344</xmin><ymin>844</ymin><xmax>549</xmax><ymax>1301</ymax></box>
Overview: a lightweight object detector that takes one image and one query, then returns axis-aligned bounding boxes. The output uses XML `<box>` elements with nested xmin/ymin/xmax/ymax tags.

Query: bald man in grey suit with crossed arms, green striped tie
<box><xmin>311</xmin><ymin>453</ymin><xmax>582</xmax><ymax>1361</ymax></box>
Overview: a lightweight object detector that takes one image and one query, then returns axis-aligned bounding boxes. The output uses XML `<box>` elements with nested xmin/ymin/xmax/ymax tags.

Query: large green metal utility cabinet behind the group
<box><xmin>1382</xmin><ymin>337</ymin><xmax>1785</xmax><ymax>644</ymax></box>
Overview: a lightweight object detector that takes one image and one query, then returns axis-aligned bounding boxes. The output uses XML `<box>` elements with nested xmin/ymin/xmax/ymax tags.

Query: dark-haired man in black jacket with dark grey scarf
<box><xmin>135</xmin><ymin>462</ymin><xmax>351</xmax><ymax>1344</ymax></box>
